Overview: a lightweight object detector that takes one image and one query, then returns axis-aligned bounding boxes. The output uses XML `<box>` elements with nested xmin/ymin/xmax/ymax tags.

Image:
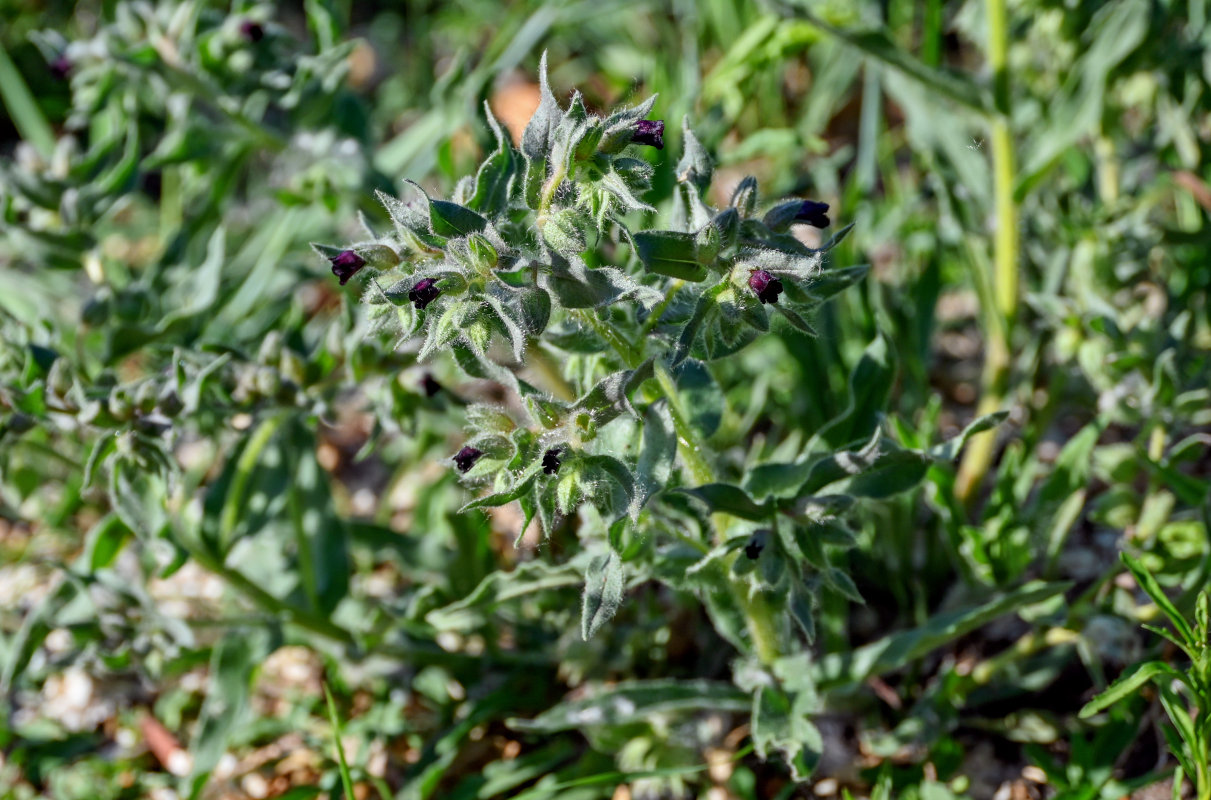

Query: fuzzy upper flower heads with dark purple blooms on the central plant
<box><xmin>316</xmin><ymin>54</ymin><xmax>863</xmax><ymax>530</ymax></box>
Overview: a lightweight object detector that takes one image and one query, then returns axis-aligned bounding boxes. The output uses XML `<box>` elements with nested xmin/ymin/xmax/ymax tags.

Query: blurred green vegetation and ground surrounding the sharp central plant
<box><xmin>0</xmin><ymin>0</ymin><xmax>1211</xmax><ymax>800</ymax></box>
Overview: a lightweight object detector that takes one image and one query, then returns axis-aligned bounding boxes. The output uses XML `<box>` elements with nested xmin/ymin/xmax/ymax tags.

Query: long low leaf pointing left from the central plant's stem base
<box><xmin>507</xmin><ymin>680</ymin><xmax>751</xmax><ymax>733</ymax></box>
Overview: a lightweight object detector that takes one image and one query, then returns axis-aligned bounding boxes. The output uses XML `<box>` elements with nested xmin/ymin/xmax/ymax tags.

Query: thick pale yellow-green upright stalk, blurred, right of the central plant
<box><xmin>954</xmin><ymin>0</ymin><xmax>1018</xmax><ymax>501</ymax></box>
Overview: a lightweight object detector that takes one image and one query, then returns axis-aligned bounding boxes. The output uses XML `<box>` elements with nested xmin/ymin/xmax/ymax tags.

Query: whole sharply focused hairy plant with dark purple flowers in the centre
<box><xmin>316</xmin><ymin>54</ymin><xmax>994</xmax><ymax>776</ymax></box>
